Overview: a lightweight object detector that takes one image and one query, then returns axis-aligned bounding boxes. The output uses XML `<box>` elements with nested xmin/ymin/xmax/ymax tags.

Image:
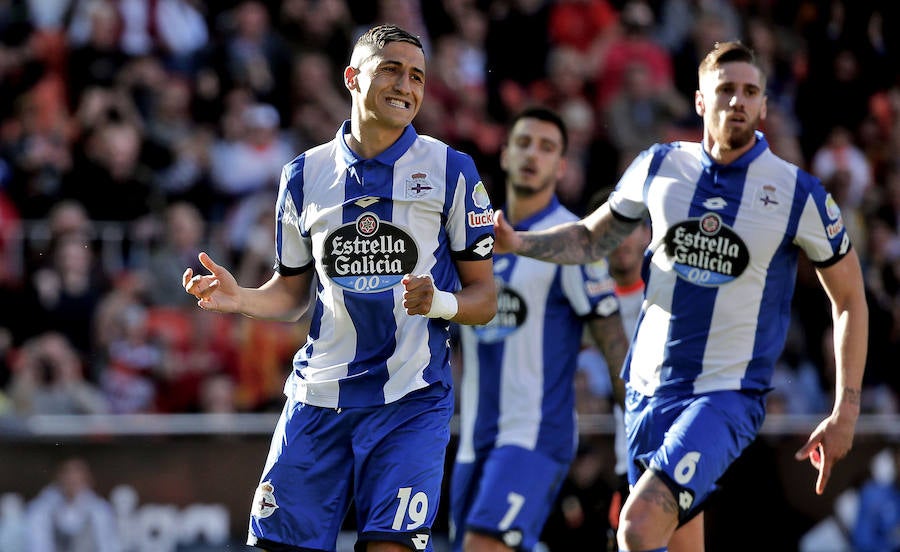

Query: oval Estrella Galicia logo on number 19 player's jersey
<box><xmin>322</xmin><ymin>212</ymin><xmax>419</xmax><ymax>293</ymax></box>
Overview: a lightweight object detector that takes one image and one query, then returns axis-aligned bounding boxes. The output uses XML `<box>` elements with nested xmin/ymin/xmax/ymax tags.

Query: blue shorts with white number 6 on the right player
<box><xmin>625</xmin><ymin>387</ymin><xmax>766</xmax><ymax>522</ymax></box>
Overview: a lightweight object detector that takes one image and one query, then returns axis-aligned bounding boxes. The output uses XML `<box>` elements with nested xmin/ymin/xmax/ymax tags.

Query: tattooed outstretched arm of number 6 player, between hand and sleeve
<box><xmin>516</xmin><ymin>214</ymin><xmax>640</xmax><ymax>264</ymax></box>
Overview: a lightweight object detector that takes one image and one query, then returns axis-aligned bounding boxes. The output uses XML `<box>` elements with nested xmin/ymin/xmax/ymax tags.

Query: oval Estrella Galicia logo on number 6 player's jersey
<box><xmin>665</xmin><ymin>213</ymin><xmax>750</xmax><ymax>286</ymax></box>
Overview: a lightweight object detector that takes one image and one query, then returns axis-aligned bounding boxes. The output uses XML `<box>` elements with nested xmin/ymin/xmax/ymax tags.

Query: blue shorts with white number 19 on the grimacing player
<box><xmin>247</xmin><ymin>386</ymin><xmax>453</xmax><ymax>551</ymax></box>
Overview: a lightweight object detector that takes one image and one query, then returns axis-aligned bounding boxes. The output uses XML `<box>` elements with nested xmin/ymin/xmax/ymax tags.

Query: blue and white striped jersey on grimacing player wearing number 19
<box><xmin>276</xmin><ymin>121</ymin><xmax>494</xmax><ymax>408</ymax></box>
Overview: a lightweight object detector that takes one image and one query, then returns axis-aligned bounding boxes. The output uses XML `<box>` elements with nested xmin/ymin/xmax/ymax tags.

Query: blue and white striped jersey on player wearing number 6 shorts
<box><xmin>609</xmin><ymin>132</ymin><xmax>850</xmax><ymax>395</ymax></box>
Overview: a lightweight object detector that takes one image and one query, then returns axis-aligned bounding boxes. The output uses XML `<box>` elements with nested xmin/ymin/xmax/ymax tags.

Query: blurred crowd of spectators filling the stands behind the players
<box><xmin>0</xmin><ymin>0</ymin><xmax>900</xmax><ymax>422</ymax></box>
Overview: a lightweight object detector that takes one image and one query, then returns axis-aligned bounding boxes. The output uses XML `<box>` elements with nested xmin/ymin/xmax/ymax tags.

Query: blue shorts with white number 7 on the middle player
<box><xmin>450</xmin><ymin>446</ymin><xmax>569</xmax><ymax>552</ymax></box>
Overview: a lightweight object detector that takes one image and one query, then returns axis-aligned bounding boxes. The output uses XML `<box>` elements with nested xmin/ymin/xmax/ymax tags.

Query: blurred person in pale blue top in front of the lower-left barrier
<box><xmin>26</xmin><ymin>458</ymin><xmax>122</xmax><ymax>552</ymax></box>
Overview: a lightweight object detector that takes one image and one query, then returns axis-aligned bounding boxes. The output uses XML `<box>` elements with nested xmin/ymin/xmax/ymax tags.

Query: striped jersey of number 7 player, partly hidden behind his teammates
<box><xmin>457</xmin><ymin>198</ymin><xmax>619</xmax><ymax>462</ymax></box>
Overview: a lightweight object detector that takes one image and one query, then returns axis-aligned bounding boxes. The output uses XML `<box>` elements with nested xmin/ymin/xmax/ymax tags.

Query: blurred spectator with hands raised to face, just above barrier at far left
<box><xmin>9</xmin><ymin>332</ymin><xmax>109</xmax><ymax>416</ymax></box>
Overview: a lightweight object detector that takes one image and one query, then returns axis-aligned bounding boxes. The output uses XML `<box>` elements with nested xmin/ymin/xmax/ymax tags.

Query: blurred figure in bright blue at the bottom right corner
<box><xmin>851</xmin><ymin>443</ymin><xmax>900</xmax><ymax>552</ymax></box>
